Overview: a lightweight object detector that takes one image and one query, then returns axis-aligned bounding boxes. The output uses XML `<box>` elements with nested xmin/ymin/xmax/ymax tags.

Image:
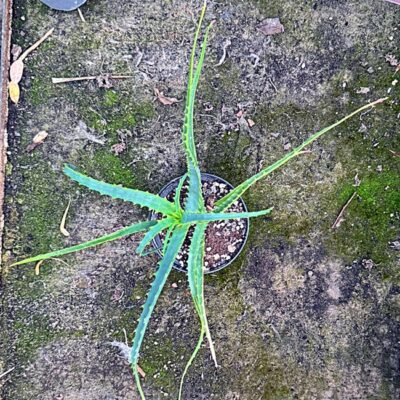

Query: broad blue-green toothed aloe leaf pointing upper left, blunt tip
<box><xmin>64</xmin><ymin>165</ymin><xmax>175</xmax><ymax>216</ymax></box>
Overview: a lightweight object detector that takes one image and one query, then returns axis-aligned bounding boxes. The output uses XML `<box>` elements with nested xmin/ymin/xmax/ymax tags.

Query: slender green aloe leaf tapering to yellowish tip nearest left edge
<box><xmin>12</xmin><ymin>221</ymin><xmax>157</xmax><ymax>266</ymax></box>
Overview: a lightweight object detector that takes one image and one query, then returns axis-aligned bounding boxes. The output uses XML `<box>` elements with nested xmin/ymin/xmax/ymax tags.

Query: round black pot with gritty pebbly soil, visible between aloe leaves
<box><xmin>149</xmin><ymin>173</ymin><xmax>250</xmax><ymax>274</ymax></box>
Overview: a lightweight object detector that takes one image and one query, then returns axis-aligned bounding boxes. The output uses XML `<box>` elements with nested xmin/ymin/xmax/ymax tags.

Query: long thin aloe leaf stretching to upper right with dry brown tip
<box><xmin>214</xmin><ymin>97</ymin><xmax>387</xmax><ymax>213</ymax></box>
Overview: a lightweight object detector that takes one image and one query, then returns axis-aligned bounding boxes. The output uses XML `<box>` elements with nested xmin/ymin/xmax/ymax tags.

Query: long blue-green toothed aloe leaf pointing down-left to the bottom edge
<box><xmin>130</xmin><ymin>225</ymin><xmax>189</xmax><ymax>399</ymax></box>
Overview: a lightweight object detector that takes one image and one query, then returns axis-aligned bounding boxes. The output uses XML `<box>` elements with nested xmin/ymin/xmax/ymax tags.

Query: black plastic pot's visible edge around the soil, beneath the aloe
<box><xmin>149</xmin><ymin>172</ymin><xmax>250</xmax><ymax>274</ymax></box>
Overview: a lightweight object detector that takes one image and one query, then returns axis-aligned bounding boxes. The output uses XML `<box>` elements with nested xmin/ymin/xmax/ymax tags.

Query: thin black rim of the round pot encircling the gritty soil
<box><xmin>149</xmin><ymin>172</ymin><xmax>250</xmax><ymax>274</ymax></box>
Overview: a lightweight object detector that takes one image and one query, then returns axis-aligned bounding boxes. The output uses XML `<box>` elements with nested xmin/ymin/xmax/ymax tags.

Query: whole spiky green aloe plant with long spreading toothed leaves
<box><xmin>13</xmin><ymin>2</ymin><xmax>386</xmax><ymax>399</ymax></box>
